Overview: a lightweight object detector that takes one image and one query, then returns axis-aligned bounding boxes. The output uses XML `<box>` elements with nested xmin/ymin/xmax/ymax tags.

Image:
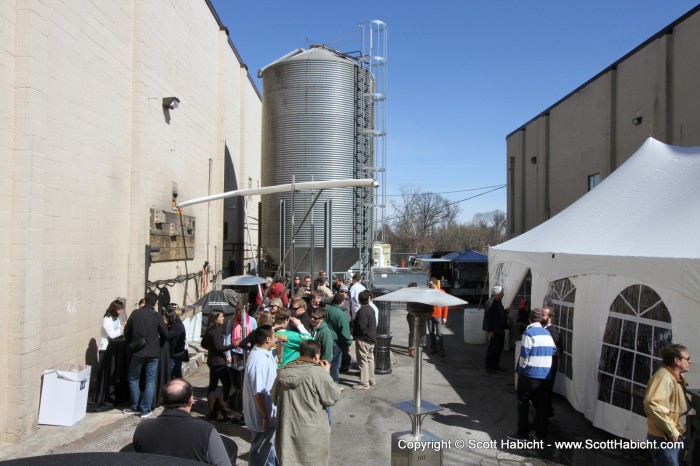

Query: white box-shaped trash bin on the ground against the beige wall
<box><xmin>39</xmin><ymin>364</ymin><xmax>90</xmax><ymax>426</ymax></box>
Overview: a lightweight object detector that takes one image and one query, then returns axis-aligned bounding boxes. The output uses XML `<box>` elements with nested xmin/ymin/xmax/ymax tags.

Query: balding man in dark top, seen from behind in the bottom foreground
<box><xmin>134</xmin><ymin>379</ymin><xmax>238</xmax><ymax>466</ymax></box>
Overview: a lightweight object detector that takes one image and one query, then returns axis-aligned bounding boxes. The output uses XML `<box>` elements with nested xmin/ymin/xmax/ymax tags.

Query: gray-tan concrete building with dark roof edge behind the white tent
<box><xmin>506</xmin><ymin>6</ymin><xmax>700</xmax><ymax>238</ymax></box>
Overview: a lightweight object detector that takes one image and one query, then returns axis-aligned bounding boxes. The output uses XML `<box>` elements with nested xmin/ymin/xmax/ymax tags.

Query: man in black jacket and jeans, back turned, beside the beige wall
<box><xmin>124</xmin><ymin>293</ymin><xmax>168</xmax><ymax>418</ymax></box>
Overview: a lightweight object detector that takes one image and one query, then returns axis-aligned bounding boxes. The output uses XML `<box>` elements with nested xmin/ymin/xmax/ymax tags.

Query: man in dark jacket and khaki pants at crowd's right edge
<box><xmin>352</xmin><ymin>290</ymin><xmax>377</xmax><ymax>390</ymax></box>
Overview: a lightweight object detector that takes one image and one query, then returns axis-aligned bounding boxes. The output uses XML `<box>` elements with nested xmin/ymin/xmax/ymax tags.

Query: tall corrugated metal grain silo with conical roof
<box><xmin>259</xmin><ymin>47</ymin><xmax>373</xmax><ymax>273</ymax></box>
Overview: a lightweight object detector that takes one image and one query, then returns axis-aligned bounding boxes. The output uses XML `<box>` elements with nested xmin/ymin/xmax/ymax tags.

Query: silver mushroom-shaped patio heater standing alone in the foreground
<box><xmin>374</xmin><ymin>287</ymin><xmax>467</xmax><ymax>466</ymax></box>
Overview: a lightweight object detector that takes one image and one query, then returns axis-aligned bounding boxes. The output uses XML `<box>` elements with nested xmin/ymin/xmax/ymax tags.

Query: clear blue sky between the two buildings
<box><xmin>212</xmin><ymin>0</ymin><xmax>698</xmax><ymax>221</ymax></box>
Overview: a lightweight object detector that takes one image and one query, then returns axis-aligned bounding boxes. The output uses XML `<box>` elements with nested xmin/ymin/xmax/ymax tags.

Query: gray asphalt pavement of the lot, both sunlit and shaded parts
<box><xmin>0</xmin><ymin>310</ymin><xmax>649</xmax><ymax>466</ymax></box>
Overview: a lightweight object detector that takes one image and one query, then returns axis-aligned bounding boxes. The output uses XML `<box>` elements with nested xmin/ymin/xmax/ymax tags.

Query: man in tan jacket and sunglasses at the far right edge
<box><xmin>644</xmin><ymin>344</ymin><xmax>692</xmax><ymax>465</ymax></box>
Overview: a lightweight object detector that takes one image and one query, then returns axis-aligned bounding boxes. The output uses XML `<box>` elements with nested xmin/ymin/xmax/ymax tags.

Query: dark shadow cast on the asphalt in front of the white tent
<box><xmin>408</xmin><ymin>309</ymin><xmax>651</xmax><ymax>466</ymax></box>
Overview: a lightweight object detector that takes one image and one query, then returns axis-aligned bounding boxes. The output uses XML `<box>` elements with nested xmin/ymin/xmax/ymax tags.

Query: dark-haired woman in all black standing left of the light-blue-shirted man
<box><xmin>202</xmin><ymin>311</ymin><xmax>238</xmax><ymax>422</ymax></box>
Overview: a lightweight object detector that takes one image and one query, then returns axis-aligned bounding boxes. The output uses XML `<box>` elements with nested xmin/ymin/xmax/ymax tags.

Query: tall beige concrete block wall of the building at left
<box><xmin>0</xmin><ymin>0</ymin><xmax>261</xmax><ymax>441</ymax></box>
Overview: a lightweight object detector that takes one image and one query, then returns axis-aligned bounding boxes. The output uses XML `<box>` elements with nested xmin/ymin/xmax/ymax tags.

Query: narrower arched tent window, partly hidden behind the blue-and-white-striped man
<box><xmin>544</xmin><ymin>278</ymin><xmax>576</xmax><ymax>380</ymax></box>
